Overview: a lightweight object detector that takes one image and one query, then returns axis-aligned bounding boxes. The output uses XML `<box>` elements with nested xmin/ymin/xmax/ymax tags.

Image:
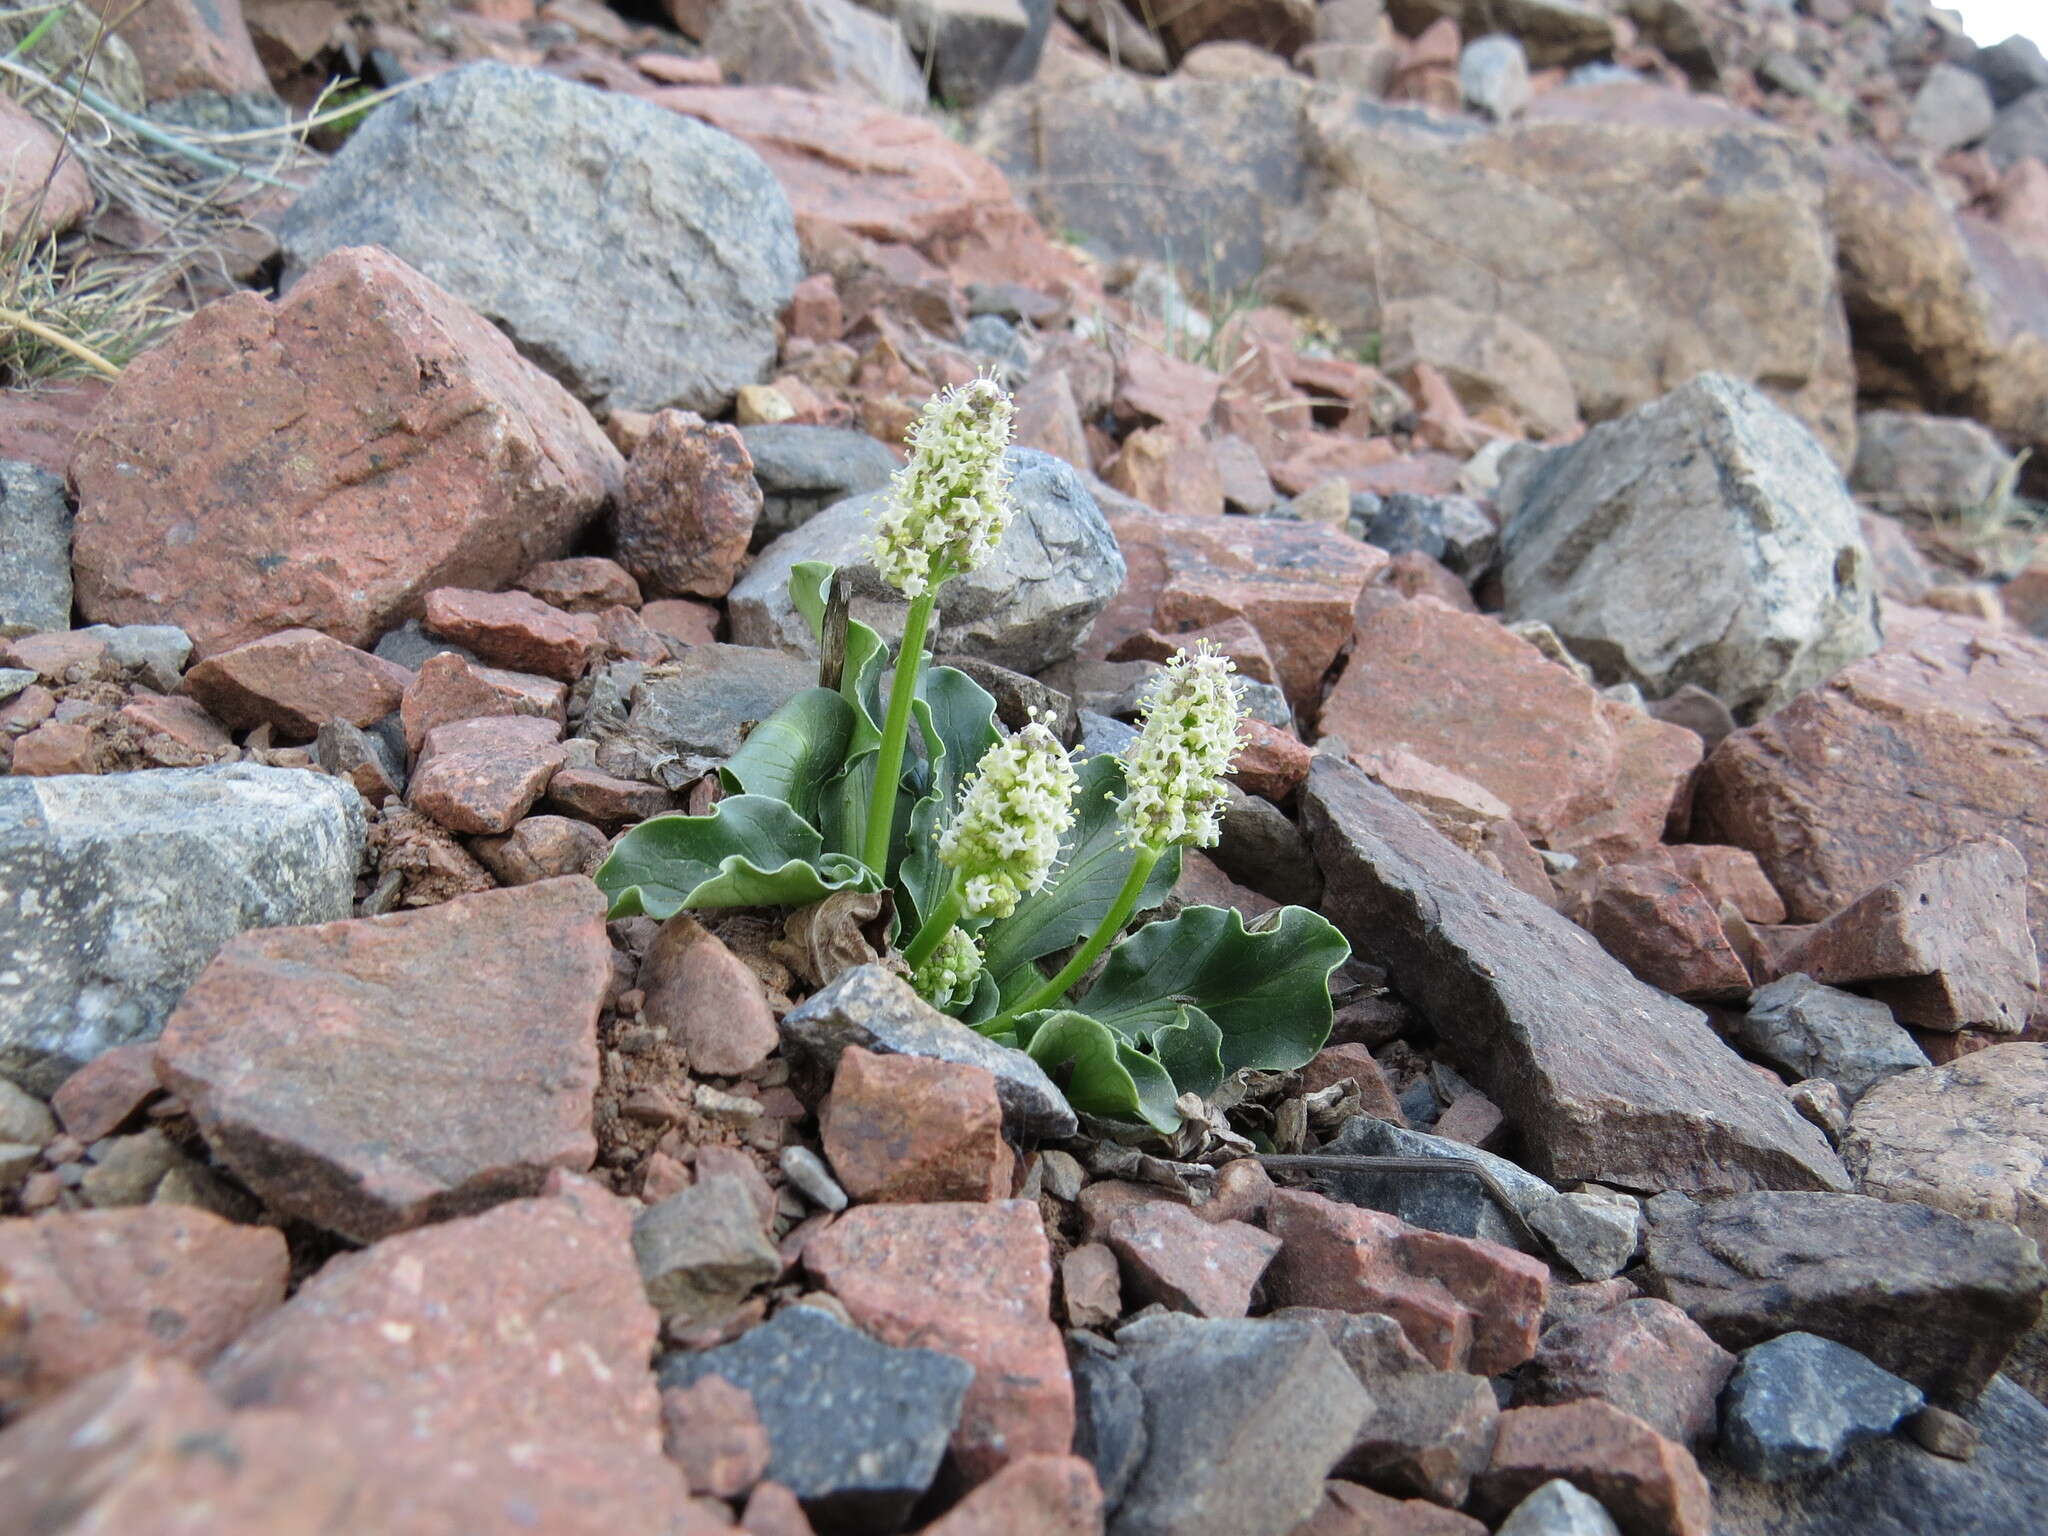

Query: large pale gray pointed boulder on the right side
<box><xmin>1501</xmin><ymin>373</ymin><xmax>1878</xmax><ymax>717</ymax></box>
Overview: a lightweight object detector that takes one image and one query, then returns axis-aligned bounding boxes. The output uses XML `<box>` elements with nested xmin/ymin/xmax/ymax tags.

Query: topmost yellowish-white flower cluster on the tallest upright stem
<box><xmin>868</xmin><ymin>379</ymin><xmax>1012</xmax><ymax>598</ymax></box>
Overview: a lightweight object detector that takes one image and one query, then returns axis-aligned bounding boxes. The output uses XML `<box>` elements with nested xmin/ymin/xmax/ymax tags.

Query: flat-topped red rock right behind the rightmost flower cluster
<box><xmin>1083</xmin><ymin>512</ymin><xmax>1386</xmax><ymax>709</ymax></box>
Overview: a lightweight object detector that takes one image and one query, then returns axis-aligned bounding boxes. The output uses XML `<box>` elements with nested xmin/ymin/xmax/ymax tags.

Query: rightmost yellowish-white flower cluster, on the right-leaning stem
<box><xmin>1118</xmin><ymin>641</ymin><xmax>1243</xmax><ymax>852</ymax></box>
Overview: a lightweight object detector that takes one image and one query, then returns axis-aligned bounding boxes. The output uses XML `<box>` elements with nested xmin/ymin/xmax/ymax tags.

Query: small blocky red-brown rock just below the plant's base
<box><xmin>817</xmin><ymin>1047</ymin><xmax>1016</xmax><ymax>1202</ymax></box>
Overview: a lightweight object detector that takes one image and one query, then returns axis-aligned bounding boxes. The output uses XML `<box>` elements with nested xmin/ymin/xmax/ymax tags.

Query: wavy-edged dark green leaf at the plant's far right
<box><xmin>1077</xmin><ymin>907</ymin><xmax>1350</xmax><ymax>1087</ymax></box>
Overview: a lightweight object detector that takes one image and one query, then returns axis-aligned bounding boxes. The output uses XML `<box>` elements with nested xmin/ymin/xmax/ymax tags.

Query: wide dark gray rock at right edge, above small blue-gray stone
<box><xmin>1640</xmin><ymin>1190</ymin><xmax>2048</xmax><ymax>1405</ymax></box>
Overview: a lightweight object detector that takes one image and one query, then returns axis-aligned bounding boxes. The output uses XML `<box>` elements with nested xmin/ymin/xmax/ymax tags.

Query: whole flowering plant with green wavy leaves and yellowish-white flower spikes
<box><xmin>598</xmin><ymin>381</ymin><xmax>1348</xmax><ymax>1133</ymax></box>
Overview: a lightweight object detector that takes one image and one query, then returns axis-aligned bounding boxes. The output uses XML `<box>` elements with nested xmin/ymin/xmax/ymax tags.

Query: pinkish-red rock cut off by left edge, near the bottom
<box><xmin>0</xmin><ymin>1206</ymin><xmax>289</xmax><ymax>1413</ymax></box>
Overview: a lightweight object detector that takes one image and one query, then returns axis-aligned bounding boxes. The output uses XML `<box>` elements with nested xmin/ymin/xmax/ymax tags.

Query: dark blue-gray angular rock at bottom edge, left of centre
<box><xmin>659</xmin><ymin>1307</ymin><xmax>975</xmax><ymax>1532</ymax></box>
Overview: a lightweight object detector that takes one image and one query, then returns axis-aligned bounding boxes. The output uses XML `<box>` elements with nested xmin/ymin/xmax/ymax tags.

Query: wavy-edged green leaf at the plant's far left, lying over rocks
<box><xmin>596</xmin><ymin>795</ymin><xmax>874</xmax><ymax>918</ymax></box>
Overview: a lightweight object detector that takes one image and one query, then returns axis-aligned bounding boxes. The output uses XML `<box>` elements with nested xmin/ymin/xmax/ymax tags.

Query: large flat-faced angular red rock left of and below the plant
<box><xmin>158</xmin><ymin>879</ymin><xmax>606</xmax><ymax>1253</ymax></box>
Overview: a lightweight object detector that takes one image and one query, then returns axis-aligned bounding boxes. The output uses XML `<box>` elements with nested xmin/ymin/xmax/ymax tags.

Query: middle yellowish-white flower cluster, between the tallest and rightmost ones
<box><xmin>938</xmin><ymin>721</ymin><xmax>1075</xmax><ymax>918</ymax></box>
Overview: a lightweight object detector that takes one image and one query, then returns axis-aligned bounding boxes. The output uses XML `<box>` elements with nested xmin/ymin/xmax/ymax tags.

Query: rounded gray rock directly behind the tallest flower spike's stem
<box><xmin>727</xmin><ymin>449</ymin><xmax>1124</xmax><ymax>674</ymax></box>
